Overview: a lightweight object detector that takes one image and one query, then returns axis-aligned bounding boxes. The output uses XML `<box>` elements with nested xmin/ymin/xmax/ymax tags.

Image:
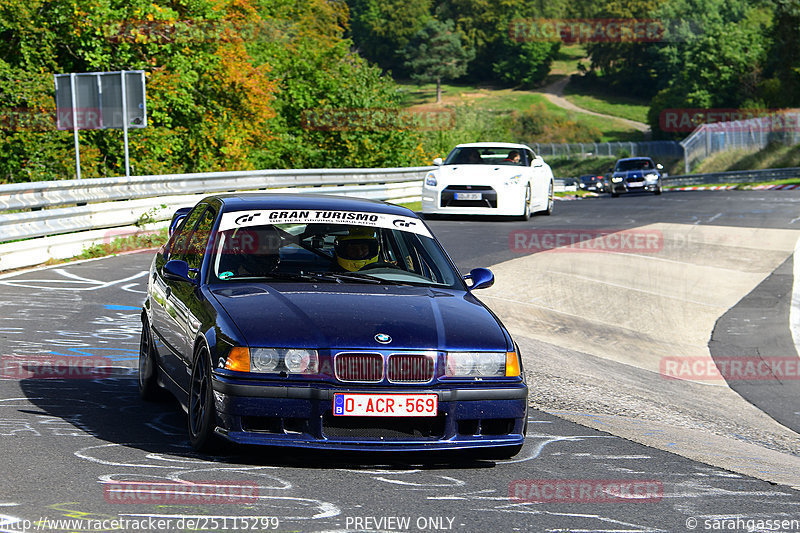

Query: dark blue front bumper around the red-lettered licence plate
<box><xmin>213</xmin><ymin>374</ymin><xmax>528</xmax><ymax>451</ymax></box>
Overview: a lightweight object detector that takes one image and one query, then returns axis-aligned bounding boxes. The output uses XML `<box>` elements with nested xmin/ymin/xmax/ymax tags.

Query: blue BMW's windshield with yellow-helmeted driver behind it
<box><xmin>211</xmin><ymin>213</ymin><xmax>463</xmax><ymax>288</ymax></box>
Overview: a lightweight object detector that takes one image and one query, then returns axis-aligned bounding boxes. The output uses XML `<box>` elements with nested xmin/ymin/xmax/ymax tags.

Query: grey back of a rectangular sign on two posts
<box><xmin>55</xmin><ymin>70</ymin><xmax>147</xmax><ymax>179</ymax></box>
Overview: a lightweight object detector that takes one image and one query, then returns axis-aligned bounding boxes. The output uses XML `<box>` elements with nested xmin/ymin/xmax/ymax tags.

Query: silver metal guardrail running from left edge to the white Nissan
<box><xmin>0</xmin><ymin>167</ymin><xmax>435</xmax><ymax>271</ymax></box>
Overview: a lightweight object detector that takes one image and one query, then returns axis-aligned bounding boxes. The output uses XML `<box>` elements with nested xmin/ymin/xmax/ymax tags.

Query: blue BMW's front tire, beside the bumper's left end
<box><xmin>188</xmin><ymin>348</ymin><xmax>222</xmax><ymax>453</ymax></box>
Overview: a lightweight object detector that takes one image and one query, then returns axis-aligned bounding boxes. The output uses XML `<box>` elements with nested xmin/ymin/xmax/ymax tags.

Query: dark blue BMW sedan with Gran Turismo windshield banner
<box><xmin>139</xmin><ymin>193</ymin><xmax>528</xmax><ymax>458</ymax></box>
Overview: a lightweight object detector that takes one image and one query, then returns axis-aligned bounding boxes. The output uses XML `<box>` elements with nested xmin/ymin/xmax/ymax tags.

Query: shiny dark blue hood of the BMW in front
<box><xmin>212</xmin><ymin>283</ymin><xmax>510</xmax><ymax>351</ymax></box>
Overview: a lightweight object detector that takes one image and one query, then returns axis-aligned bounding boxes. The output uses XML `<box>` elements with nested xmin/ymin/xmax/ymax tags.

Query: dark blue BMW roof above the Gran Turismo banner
<box><xmin>205</xmin><ymin>192</ymin><xmax>416</xmax><ymax>217</ymax></box>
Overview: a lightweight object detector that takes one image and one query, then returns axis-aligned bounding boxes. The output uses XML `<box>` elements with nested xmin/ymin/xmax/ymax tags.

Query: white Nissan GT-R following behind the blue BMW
<box><xmin>422</xmin><ymin>143</ymin><xmax>554</xmax><ymax>220</ymax></box>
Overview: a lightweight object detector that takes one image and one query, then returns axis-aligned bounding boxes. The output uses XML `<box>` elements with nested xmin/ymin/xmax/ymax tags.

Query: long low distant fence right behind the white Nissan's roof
<box><xmin>528</xmin><ymin>141</ymin><xmax>683</xmax><ymax>159</ymax></box>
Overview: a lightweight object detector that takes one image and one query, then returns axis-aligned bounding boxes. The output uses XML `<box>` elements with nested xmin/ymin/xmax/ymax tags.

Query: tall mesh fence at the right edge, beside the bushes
<box><xmin>680</xmin><ymin>112</ymin><xmax>800</xmax><ymax>174</ymax></box>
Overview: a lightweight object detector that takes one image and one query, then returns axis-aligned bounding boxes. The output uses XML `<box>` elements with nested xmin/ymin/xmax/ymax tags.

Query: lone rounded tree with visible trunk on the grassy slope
<box><xmin>403</xmin><ymin>19</ymin><xmax>475</xmax><ymax>104</ymax></box>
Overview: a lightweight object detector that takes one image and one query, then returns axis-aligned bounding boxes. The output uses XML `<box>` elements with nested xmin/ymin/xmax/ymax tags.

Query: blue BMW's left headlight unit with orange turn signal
<box><xmin>225</xmin><ymin>347</ymin><xmax>319</xmax><ymax>374</ymax></box>
